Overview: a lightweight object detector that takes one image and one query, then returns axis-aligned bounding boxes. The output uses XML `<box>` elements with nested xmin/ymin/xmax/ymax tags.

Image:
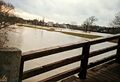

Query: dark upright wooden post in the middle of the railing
<box><xmin>78</xmin><ymin>44</ymin><xmax>90</xmax><ymax>79</ymax></box>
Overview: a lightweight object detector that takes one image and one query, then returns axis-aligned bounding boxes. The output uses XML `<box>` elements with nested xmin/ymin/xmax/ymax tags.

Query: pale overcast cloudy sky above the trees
<box><xmin>6</xmin><ymin>0</ymin><xmax>120</xmax><ymax>26</ymax></box>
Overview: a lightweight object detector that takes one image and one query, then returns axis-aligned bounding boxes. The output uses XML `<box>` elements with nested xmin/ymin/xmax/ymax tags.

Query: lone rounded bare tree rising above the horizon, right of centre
<box><xmin>82</xmin><ymin>16</ymin><xmax>97</xmax><ymax>32</ymax></box>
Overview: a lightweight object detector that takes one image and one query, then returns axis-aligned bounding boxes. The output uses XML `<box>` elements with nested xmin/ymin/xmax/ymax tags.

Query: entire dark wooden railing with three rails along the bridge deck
<box><xmin>20</xmin><ymin>34</ymin><xmax>120</xmax><ymax>82</ymax></box>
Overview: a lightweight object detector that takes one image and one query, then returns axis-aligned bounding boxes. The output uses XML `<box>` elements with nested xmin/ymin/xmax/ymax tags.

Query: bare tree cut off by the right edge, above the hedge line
<box><xmin>110</xmin><ymin>12</ymin><xmax>120</xmax><ymax>28</ymax></box>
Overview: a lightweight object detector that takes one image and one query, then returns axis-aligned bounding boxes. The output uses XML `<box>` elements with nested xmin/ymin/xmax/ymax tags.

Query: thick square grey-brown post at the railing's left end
<box><xmin>0</xmin><ymin>48</ymin><xmax>21</xmax><ymax>82</ymax></box>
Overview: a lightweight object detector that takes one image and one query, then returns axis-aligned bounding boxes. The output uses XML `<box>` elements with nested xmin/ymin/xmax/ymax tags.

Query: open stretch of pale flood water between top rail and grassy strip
<box><xmin>5</xmin><ymin>27</ymin><xmax>85</xmax><ymax>52</ymax></box>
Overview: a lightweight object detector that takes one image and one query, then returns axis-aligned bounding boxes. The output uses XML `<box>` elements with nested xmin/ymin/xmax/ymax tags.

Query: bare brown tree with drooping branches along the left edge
<box><xmin>0</xmin><ymin>0</ymin><xmax>17</xmax><ymax>48</ymax></box>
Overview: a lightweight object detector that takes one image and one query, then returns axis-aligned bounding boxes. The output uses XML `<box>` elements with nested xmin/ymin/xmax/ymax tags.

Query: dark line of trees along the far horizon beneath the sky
<box><xmin>24</xmin><ymin>13</ymin><xmax>120</xmax><ymax>34</ymax></box>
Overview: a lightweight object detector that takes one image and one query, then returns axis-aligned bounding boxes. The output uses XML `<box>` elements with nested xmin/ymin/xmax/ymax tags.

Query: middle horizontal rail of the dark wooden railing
<box><xmin>23</xmin><ymin>45</ymin><xmax>117</xmax><ymax>79</ymax></box>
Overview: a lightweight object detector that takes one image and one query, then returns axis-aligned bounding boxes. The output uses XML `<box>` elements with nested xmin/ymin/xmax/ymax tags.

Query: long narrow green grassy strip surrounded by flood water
<box><xmin>18</xmin><ymin>24</ymin><xmax>101</xmax><ymax>39</ymax></box>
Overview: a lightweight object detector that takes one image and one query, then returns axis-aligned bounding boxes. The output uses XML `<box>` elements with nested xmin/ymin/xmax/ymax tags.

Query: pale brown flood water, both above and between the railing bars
<box><xmin>0</xmin><ymin>27</ymin><xmax>115</xmax><ymax>82</ymax></box>
